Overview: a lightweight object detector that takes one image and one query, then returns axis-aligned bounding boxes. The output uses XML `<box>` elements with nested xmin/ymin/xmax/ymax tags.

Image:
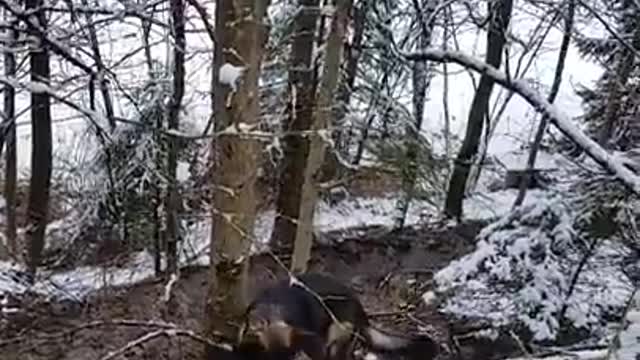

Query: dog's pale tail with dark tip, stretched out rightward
<box><xmin>363</xmin><ymin>326</ymin><xmax>440</xmax><ymax>360</ymax></box>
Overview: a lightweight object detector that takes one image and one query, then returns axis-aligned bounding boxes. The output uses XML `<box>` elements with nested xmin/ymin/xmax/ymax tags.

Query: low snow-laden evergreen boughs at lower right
<box><xmin>434</xmin><ymin>194</ymin><xmax>632</xmax><ymax>340</ymax></box>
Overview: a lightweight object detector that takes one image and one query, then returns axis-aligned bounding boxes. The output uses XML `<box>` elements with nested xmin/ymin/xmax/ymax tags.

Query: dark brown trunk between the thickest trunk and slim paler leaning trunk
<box><xmin>271</xmin><ymin>0</ymin><xmax>319</xmax><ymax>247</ymax></box>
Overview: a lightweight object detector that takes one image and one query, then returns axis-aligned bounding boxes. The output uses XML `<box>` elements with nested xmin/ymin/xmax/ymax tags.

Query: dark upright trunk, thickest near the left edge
<box><xmin>25</xmin><ymin>0</ymin><xmax>52</xmax><ymax>277</ymax></box>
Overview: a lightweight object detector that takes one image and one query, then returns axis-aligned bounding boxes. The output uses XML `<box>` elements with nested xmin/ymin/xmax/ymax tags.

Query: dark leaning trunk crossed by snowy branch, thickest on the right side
<box><xmin>445</xmin><ymin>0</ymin><xmax>513</xmax><ymax>219</ymax></box>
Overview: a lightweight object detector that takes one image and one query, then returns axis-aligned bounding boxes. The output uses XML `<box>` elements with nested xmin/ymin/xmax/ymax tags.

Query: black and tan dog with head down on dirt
<box><xmin>240</xmin><ymin>273</ymin><xmax>440</xmax><ymax>360</ymax></box>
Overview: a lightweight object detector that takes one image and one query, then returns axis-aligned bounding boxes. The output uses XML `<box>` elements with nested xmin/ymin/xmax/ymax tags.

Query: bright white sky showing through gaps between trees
<box><xmin>7</xmin><ymin>2</ymin><xmax>602</xmax><ymax>172</ymax></box>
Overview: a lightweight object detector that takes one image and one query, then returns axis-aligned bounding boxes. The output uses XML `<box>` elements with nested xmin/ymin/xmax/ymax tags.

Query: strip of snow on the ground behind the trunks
<box><xmin>0</xmin><ymin>187</ymin><xmax>541</xmax><ymax>299</ymax></box>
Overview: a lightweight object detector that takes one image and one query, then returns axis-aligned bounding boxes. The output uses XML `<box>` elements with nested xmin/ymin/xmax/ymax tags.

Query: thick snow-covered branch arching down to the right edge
<box><xmin>401</xmin><ymin>49</ymin><xmax>640</xmax><ymax>194</ymax></box>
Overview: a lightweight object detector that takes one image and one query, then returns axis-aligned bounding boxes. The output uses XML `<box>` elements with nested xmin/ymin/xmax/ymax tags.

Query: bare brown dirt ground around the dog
<box><xmin>0</xmin><ymin>219</ymin><xmax>500</xmax><ymax>360</ymax></box>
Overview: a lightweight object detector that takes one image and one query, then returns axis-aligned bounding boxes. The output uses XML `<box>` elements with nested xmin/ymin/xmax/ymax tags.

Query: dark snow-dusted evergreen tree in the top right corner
<box><xmin>576</xmin><ymin>0</ymin><xmax>640</xmax><ymax>151</ymax></box>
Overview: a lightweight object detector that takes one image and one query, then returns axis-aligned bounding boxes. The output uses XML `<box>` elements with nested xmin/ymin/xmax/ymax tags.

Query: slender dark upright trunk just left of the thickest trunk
<box><xmin>165</xmin><ymin>0</ymin><xmax>186</xmax><ymax>274</ymax></box>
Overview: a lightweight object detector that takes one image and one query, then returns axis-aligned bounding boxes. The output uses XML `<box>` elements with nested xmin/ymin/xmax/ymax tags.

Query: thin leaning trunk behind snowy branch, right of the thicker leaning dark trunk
<box><xmin>513</xmin><ymin>0</ymin><xmax>576</xmax><ymax>209</ymax></box>
